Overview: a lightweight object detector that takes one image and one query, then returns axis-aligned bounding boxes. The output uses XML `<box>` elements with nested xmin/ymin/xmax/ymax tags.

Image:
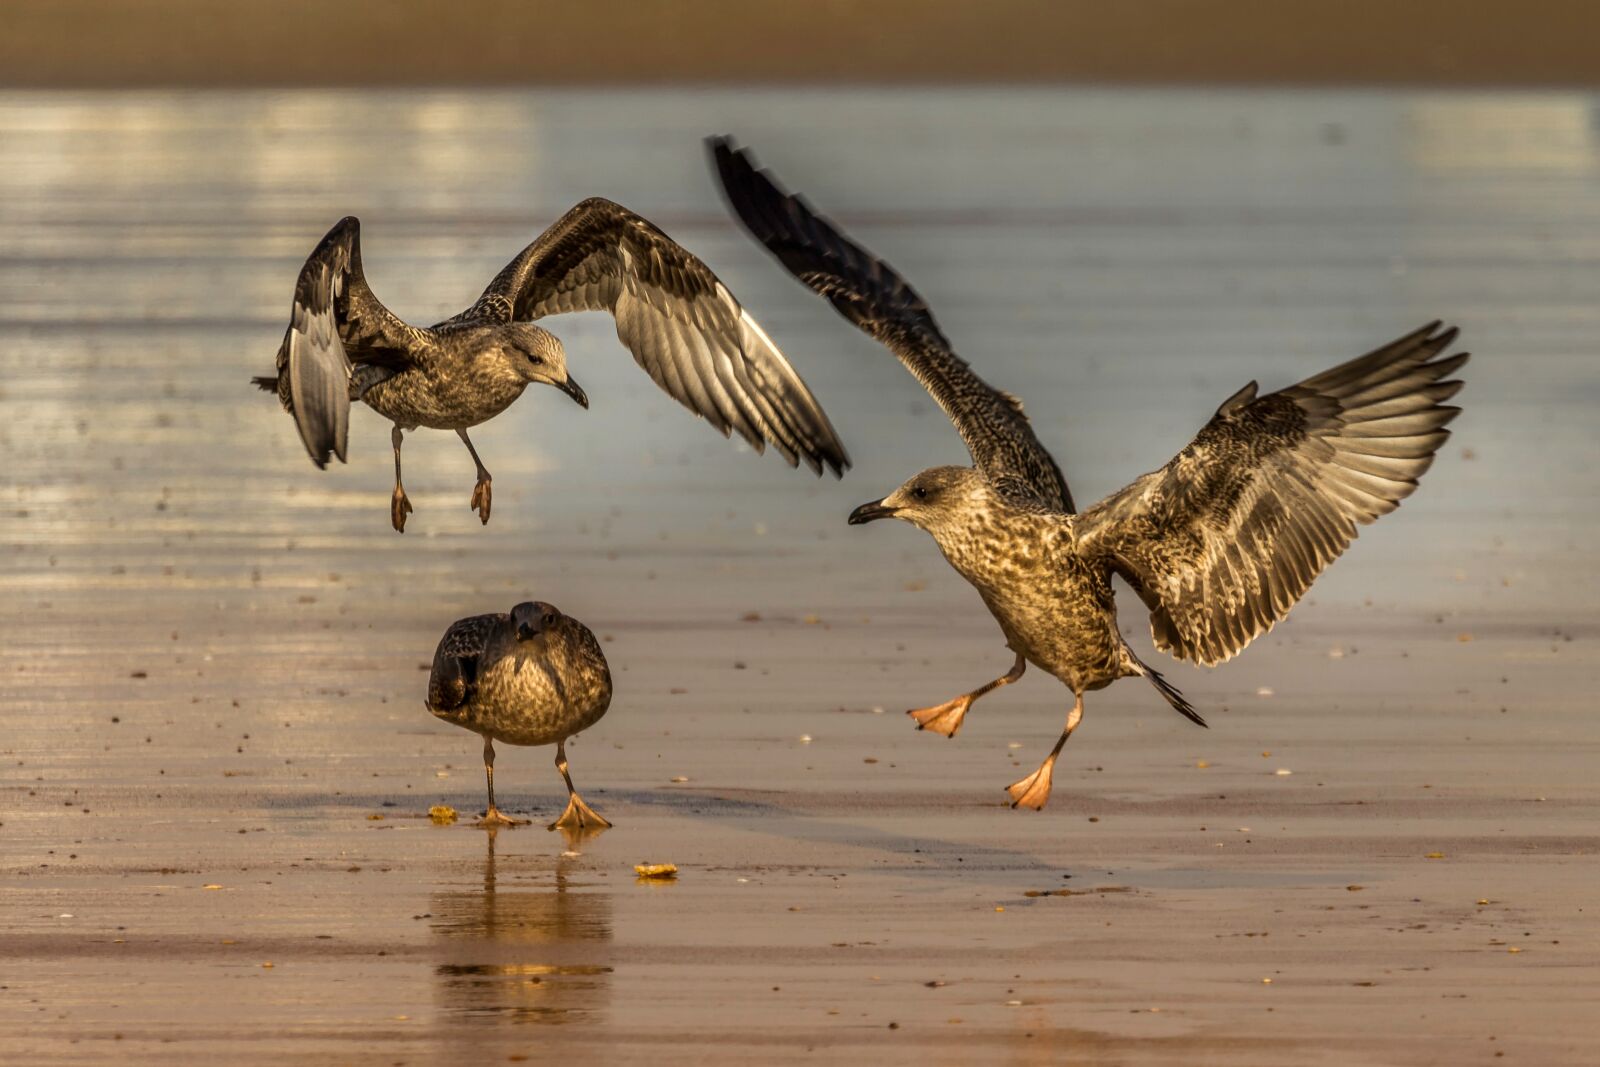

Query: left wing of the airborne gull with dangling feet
<box><xmin>270</xmin><ymin>216</ymin><xmax>416</xmax><ymax>467</ymax></box>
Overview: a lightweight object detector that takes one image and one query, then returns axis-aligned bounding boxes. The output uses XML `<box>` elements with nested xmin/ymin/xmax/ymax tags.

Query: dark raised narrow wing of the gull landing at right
<box><xmin>709</xmin><ymin>138</ymin><xmax>1072</xmax><ymax>512</ymax></box>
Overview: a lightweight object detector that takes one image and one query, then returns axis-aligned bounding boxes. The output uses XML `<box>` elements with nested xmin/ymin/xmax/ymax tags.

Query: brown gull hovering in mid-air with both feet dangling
<box><xmin>251</xmin><ymin>197</ymin><xmax>850</xmax><ymax>533</ymax></box>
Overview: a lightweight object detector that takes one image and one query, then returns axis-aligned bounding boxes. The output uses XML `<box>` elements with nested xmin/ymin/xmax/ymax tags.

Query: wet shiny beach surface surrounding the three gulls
<box><xmin>0</xmin><ymin>91</ymin><xmax>1600</xmax><ymax>1065</ymax></box>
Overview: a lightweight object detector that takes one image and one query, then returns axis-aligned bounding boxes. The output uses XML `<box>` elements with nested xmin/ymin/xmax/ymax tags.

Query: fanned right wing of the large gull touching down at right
<box><xmin>1077</xmin><ymin>323</ymin><xmax>1467</xmax><ymax>665</ymax></box>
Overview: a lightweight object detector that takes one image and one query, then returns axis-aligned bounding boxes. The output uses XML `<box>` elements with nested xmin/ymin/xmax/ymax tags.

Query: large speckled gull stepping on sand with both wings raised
<box><xmin>712</xmin><ymin>139</ymin><xmax>1467</xmax><ymax>808</ymax></box>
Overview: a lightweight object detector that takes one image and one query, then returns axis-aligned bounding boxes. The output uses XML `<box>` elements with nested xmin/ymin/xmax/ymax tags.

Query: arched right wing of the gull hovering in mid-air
<box><xmin>467</xmin><ymin>197</ymin><xmax>850</xmax><ymax>475</ymax></box>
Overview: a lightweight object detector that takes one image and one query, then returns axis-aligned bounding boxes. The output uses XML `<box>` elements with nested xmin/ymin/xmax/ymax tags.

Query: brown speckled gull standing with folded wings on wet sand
<box><xmin>427</xmin><ymin>601</ymin><xmax>611</xmax><ymax>830</ymax></box>
